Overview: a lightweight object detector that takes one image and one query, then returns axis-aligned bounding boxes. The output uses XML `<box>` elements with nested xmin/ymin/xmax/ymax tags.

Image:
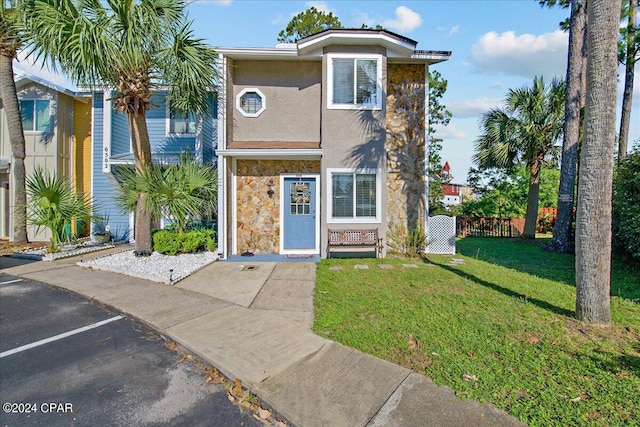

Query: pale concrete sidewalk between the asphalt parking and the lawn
<box><xmin>0</xmin><ymin>251</ymin><xmax>524</xmax><ymax>427</ymax></box>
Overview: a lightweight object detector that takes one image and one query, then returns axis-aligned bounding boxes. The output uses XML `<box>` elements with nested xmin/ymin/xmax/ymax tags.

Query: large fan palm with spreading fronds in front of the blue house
<box><xmin>27</xmin><ymin>0</ymin><xmax>215</xmax><ymax>256</ymax></box>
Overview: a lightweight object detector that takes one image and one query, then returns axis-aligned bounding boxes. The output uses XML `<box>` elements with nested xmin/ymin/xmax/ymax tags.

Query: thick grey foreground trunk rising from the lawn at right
<box><xmin>576</xmin><ymin>0</ymin><xmax>621</xmax><ymax>324</ymax></box>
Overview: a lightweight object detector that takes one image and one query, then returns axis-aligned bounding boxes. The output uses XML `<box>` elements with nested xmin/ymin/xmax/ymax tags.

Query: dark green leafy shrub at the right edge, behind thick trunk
<box><xmin>613</xmin><ymin>148</ymin><xmax>640</xmax><ymax>262</ymax></box>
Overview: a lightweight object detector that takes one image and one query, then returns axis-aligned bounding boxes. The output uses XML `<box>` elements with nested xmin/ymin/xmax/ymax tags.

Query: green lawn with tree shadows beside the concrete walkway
<box><xmin>314</xmin><ymin>238</ymin><xmax>640</xmax><ymax>426</ymax></box>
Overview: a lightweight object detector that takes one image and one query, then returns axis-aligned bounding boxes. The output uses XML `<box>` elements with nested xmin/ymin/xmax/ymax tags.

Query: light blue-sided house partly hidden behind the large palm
<box><xmin>91</xmin><ymin>92</ymin><xmax>217</xmax><ymax>241</ymax></box>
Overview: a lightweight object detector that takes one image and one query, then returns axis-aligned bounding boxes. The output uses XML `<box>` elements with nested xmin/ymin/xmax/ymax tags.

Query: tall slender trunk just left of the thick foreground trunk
<box><xmin>545</xmin><ymin>0</ymin><xmax>587</xmax><ymax>253</ymax></box>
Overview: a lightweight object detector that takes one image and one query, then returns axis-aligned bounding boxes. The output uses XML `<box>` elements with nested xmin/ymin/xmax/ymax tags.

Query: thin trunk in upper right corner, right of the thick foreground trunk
<box><xmin>618</xmin><ymin>0</ymin><xmax>638</xmax><ymax>164</ymax></box>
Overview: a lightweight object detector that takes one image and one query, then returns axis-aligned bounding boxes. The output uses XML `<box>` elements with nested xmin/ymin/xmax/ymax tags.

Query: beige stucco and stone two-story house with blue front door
<box><xmin>216</xmin><ymin>29</ymin><xmax>450</xmax><ymax>258</ymax></box>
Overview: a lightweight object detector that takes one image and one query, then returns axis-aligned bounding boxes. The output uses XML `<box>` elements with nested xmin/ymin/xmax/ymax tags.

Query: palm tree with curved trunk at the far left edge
<box><xmin>0</xmin><ymin>1</ymin><xmax>27</xmax><ymax>242</ymax></box>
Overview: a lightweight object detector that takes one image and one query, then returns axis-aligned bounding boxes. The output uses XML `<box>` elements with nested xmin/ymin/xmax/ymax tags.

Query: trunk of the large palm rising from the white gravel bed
<box><xmin>127</xmin><ymin>108</ymin><xmax>152</xmax><ymax>256</ymax></box>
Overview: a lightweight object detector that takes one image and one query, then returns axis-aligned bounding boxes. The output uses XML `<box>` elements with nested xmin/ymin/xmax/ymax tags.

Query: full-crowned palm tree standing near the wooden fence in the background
<box><xmin>474</xmin><ymin>77</ymin><xmax>565</xmax><ymax>239</ymax></box>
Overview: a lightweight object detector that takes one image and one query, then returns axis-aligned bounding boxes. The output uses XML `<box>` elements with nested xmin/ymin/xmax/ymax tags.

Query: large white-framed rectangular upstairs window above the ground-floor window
<box><xmin>328</xmin><ymin>55</ymin><xmax>382</xmax><ymax>109</ymax></box>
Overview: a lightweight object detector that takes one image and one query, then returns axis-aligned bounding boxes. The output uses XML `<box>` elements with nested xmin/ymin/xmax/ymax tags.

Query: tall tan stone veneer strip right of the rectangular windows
<box><xmin>385</xmin><ymin>64</ymin><xmax>427</xmax><ymax>251</ymax></box>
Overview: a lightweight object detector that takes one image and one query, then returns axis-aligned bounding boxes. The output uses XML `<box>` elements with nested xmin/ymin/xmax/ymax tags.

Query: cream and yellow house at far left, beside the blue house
<box><xmin>0</xmin><ymin>76</ymin><xmax>91</xmax><ymax>241</ymax></box>
